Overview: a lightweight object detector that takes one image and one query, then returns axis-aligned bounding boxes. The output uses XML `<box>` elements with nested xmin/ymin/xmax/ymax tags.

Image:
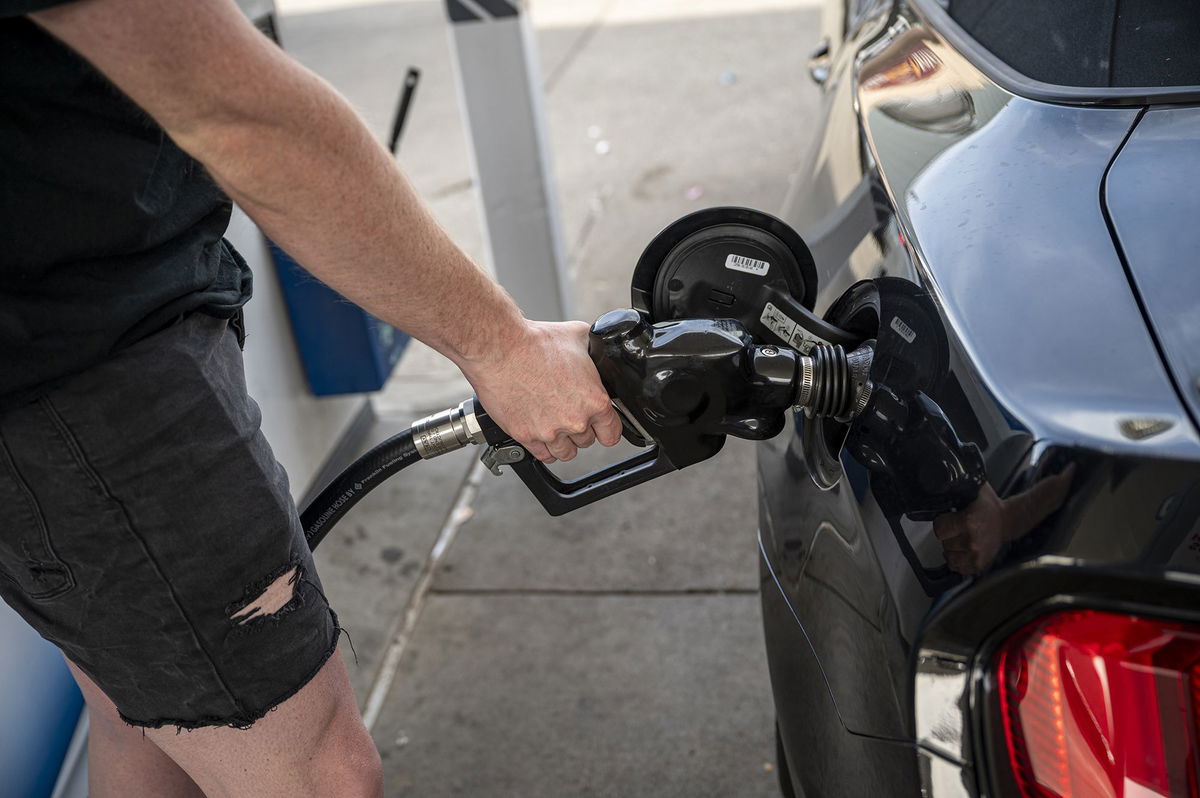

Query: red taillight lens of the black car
<box><xmin>996</xmin><ymin>611</ymin><xmax>1200</xmax><ymax>798</ymax></box>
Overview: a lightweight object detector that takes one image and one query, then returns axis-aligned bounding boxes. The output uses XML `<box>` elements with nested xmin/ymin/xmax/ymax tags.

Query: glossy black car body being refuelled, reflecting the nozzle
<box><xmin>758</xmin><ymin>0</ymin><xmax>1200</xmax><ymax>798</ymax></box>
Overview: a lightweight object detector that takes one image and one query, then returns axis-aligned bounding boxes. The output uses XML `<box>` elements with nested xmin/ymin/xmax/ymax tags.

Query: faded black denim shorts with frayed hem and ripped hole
<box><xmin>0</xmin><ymin>314</ymin><xmax>338</xmax><ymax>728</ymax></box>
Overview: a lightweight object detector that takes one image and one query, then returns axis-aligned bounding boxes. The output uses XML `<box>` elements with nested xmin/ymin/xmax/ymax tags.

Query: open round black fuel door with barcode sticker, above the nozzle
<box><xmin>631</xmin><ymin>208</ymin><xmax>817</xmax><ymax>329</ymax></box>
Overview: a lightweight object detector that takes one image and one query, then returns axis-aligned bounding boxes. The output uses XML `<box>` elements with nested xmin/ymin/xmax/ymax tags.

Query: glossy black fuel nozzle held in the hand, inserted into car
<box><xmin>458</xmin><ymin>304</ymin><xmax>874</xmax><ymax>515</ymax></box>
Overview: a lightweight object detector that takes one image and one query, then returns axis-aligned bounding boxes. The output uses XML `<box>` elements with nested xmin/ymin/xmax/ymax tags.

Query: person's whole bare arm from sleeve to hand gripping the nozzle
<box><xmin>32</xmin><ymin>0</ymin><xmax>620</xmax><ymax>461</ymax></box>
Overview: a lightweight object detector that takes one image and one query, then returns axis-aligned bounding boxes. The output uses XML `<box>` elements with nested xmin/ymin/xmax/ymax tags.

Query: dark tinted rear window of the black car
<box><xmin>938</xmin><ymin>0</ymin><xmax>1200</xmax><ymax>88</ymax></box>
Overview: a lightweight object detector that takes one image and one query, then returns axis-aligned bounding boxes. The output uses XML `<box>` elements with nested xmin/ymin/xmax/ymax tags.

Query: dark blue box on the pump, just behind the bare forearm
<box><xmin>270</xmin><ymin>244</ymin><xmax>408</xmax><ymax>396</ymax></box>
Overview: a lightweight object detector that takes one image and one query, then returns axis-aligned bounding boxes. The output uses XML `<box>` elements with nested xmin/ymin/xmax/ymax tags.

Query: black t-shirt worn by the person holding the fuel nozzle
<box><xmin>0</xmin><ymin>0</ymin><xmax>251</xmax><ymax>407</ymax></box>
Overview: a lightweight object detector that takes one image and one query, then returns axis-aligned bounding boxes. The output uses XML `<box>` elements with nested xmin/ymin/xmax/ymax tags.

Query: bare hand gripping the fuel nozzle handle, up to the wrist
<box><xmin>463</xmin><ymin>322</ymin><xmax>620</xmax><ymax>463</ymax></box>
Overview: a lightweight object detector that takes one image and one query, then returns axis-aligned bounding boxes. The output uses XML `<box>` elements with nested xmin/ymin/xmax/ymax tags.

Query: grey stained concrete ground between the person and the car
<box><xmin>280</xmin><ymin>0</ymin><xmax>820</xmax><ymax>798</ymax></box>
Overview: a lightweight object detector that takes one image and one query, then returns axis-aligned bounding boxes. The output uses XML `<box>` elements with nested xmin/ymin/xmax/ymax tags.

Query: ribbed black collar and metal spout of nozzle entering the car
<box><xmin>796</xmin><ymin>341</ymin><xmax>875</xmax><ymax>422</ymax></box>
